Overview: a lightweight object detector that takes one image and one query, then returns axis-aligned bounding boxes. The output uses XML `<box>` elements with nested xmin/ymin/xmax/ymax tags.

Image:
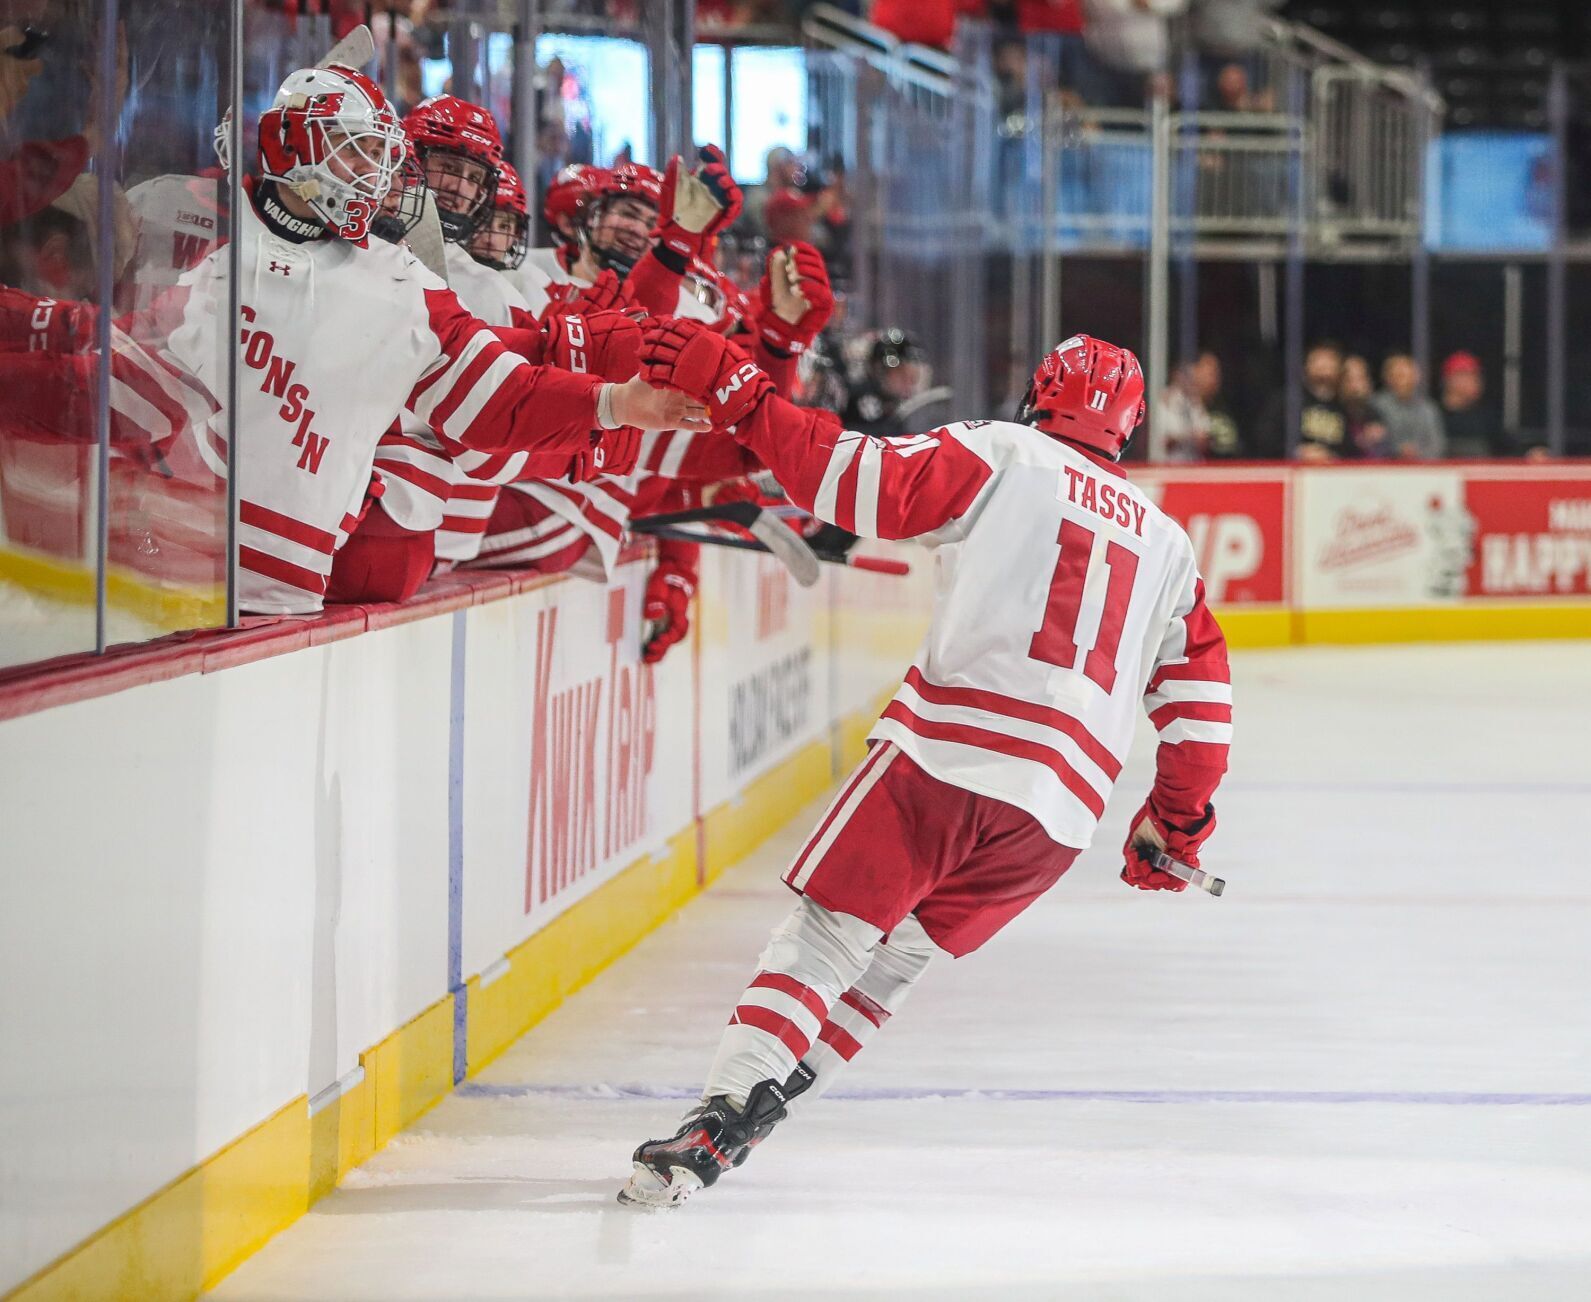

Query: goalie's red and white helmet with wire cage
<box><xmin>259</xmin><ymin>65</ymin><xmax>409</xmax><ymax>240</ymax></box>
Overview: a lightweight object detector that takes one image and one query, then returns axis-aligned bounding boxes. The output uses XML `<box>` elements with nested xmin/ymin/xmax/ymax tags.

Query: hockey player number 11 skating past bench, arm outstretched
<box><xmin>619</xmin><ymin>322</ymin><xmax>1231</xmax><ymax>1206</ymax></box>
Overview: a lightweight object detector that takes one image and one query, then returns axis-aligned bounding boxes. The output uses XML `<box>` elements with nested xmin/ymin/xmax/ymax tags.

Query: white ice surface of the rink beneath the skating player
<box><xmin>205</xmin><ymin>643</ymin><xmax>1591</xmax><ymax>1302</ymax></box>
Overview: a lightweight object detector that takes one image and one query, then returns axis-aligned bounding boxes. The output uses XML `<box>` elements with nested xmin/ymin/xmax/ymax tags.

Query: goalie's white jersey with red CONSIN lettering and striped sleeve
<box><xmin>169</xmin><ymin>191</ymin><xmax>601</xmax><ymax>614</ymax></box>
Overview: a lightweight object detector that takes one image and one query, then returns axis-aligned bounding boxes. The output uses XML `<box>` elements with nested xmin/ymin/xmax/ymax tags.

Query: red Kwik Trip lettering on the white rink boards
<box><xmin>525</xmin><ymin>587</ymin><xmax>657</xmax><ymax>914</ymax></box>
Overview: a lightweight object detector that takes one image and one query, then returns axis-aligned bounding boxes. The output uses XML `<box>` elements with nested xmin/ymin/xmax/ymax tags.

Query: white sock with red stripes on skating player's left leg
<box><xmin>702</xmin><ymin>899</ymin><xmax>880</xmax><ymax>1106</ymax></box>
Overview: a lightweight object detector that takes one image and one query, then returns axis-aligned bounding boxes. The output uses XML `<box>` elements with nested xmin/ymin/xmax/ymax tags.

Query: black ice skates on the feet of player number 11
<box><xmin>619</xmin><ymin>1063</ymin><xmax>816</xmax><ymax>1206</ymax></box>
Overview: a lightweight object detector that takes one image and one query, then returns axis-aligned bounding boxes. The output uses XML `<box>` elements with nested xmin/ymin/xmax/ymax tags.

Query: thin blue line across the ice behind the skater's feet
<box><xmin>458</xmin><ymin>1081</ymin><xmax>1591</xmax><ymax>1108</ymax></box>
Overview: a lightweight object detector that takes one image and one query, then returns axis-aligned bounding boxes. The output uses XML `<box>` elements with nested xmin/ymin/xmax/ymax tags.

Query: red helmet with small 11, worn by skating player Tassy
<box><xmin>1017</xmin><ymin>334</ymin><xmax>1144</xmax><ymax>462</ymax></box>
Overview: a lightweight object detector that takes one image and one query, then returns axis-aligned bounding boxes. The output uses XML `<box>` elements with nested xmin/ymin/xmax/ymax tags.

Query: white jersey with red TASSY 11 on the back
<box><xmin>737</xmin><ymin>410</ymin><xmax>1231</xmax><ymax>848</ymax></box>
